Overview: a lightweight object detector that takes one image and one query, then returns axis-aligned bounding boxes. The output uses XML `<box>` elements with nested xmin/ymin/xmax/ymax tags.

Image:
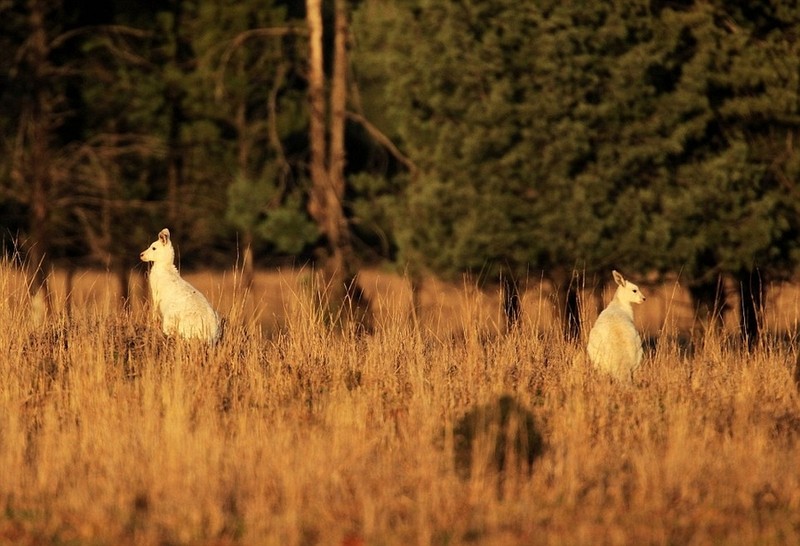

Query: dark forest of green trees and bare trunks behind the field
<box><xmin>0</xmin><ymin>0</ymin><xmax>800</xmax><ymax>339</ymax></box>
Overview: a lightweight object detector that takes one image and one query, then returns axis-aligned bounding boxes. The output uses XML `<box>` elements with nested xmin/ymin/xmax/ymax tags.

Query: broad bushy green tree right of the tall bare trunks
<box><xmin>357</xmin><ymin>0</ymin><xmax>668</xmax><ymax>337</ymax></box>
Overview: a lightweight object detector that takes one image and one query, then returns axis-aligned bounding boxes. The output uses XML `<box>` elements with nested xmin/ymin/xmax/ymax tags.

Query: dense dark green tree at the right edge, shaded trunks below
<box><xmin>654</xmin><ymin>2</ymin><xmax>800</xmax><ymax>345</ymax></box>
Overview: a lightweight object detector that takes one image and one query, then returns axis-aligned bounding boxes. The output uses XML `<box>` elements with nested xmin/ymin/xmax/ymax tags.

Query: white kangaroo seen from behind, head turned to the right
<box><xmin>587</xmin><ymin>271</ymin><xmax>645</xmax><ymax>382</ymax></box>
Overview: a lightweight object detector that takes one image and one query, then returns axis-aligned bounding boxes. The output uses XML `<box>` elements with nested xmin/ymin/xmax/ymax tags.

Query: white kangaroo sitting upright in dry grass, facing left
<box><xmin>139</xmin><ymin>228</ymin><xmax>219</xmax><ymax>343</ymax></box>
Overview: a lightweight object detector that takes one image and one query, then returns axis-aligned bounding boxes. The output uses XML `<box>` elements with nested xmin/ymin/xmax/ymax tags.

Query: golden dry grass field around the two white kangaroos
<box><xmin>0</xmin><ymin>265</ymin><xmax>800</xmax><ymax>546</ymax></box>
